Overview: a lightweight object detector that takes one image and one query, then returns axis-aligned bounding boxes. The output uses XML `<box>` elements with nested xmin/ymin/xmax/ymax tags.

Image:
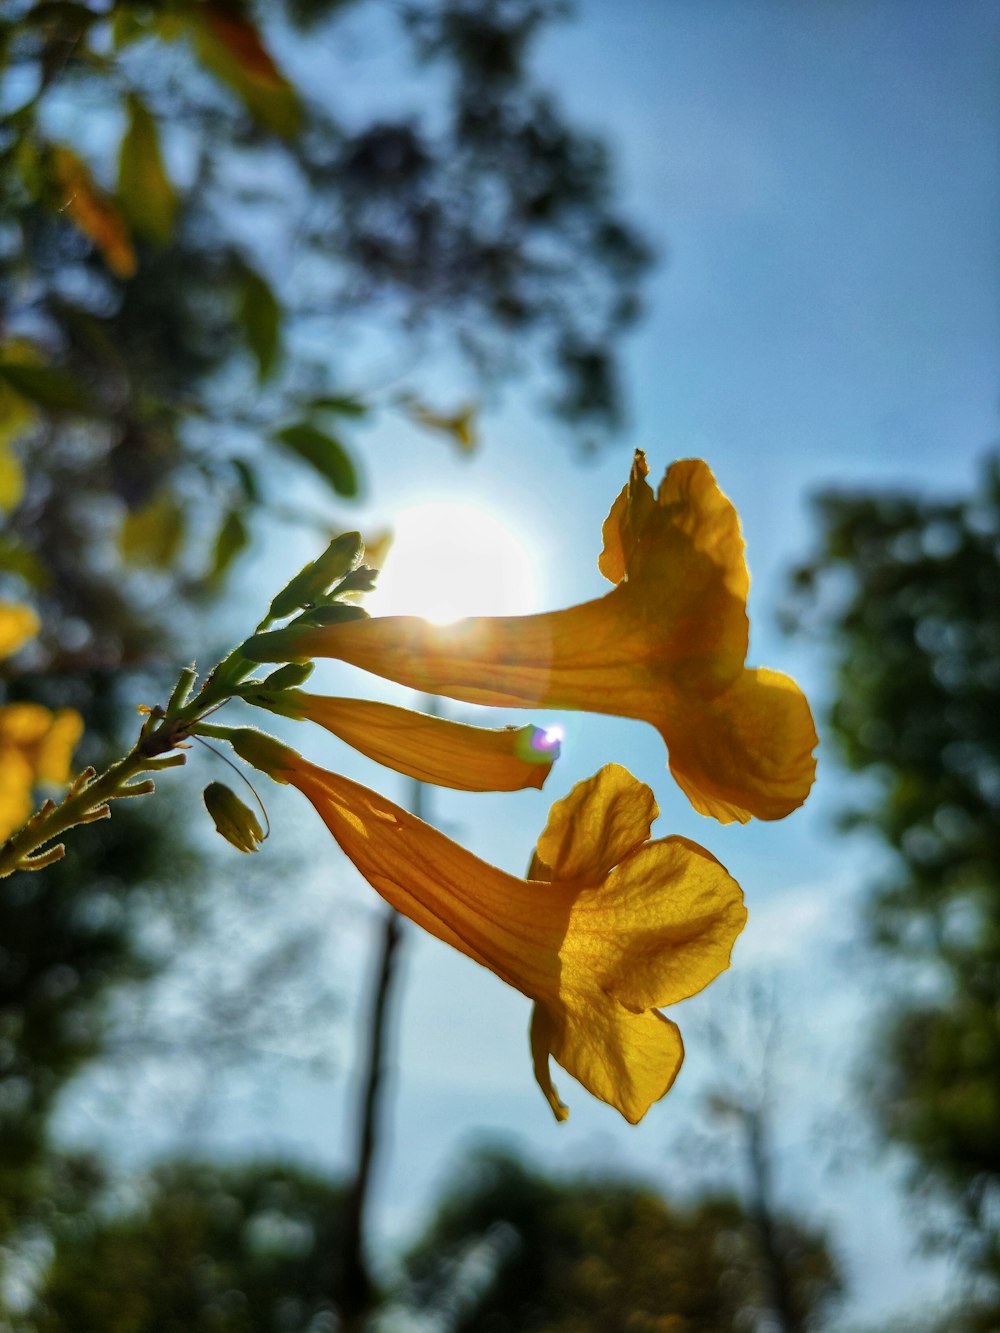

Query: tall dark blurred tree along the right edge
<box><xmin>789</xmin><ymin>457</ymin><xmax>1000</xmax><ymax>1328</ymax></box>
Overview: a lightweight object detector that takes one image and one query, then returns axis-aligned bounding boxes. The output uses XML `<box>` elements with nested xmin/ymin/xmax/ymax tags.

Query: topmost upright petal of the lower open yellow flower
<box><xmin>528</xmin><ymin>764</ymin><xmax>660</xmax><ymax>884</ymax></box>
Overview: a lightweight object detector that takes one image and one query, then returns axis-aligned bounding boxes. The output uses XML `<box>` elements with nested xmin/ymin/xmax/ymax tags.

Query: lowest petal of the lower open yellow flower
<box><xmin>532</xmin><ymin>990</ymin><xmax>684</xmax><ymax>1125</ymax></box>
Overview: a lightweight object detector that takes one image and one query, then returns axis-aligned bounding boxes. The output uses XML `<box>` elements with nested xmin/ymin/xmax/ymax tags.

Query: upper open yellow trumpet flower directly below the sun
<box><xmin>243</xmin><ymin>453</ymin><xmax>816</xmax><ymax>824</ymax></box>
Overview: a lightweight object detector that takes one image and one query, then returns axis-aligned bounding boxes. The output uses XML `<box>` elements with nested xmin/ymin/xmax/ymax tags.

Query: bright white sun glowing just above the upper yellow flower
<box><xmin>365</xmin><ymin>501</ymin><xmax>535</xmax><ymax>625</ymax></box>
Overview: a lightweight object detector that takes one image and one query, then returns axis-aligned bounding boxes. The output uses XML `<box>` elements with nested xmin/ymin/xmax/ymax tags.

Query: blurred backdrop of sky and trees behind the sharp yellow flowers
<box><xmin>0</xmin><ymin>0</ymin><xmax>1000</xmax><ymax>1333</ymax></box>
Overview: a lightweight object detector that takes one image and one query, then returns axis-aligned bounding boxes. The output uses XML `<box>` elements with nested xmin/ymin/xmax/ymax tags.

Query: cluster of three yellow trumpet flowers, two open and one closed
<box><xmin>217</xmin><ymin>453</ymin><xmax>816</xmax><ymax>1121</ymax></box>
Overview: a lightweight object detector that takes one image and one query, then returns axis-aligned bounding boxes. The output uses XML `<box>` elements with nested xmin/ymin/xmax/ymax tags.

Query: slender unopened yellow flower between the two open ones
<box><xmin>248</xmin><ymin>689</ymin><xmax>559</xmax><ymax>792</ymax></box>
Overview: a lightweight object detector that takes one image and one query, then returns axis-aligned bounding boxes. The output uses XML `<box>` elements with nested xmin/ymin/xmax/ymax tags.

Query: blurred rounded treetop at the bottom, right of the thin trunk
<box><xmin>407</xmin><ymin>1152</ymin><xmax>839</xmax><ymax>1333</ymax></box>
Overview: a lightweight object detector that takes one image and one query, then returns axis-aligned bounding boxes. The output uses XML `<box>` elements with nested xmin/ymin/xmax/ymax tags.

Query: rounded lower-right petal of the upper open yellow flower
<box><xmin>660</xmin><ymin>668</ymin><xmax>817</xmax><ymax>824</ymax></box>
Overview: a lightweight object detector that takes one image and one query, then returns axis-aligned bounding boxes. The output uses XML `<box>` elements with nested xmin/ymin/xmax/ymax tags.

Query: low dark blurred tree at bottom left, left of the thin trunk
<box><xmin>21</xmin><ymin>1162</ymin><xmax>349</xmax><ymax>1333</ymax></box>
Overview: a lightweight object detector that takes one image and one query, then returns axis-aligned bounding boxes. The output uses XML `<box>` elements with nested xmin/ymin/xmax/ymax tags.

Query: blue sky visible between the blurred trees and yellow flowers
<box><xmin>56</xmin><ymin>0</ymin><xmax>1000</xmax><ymax>1317</ymax></box>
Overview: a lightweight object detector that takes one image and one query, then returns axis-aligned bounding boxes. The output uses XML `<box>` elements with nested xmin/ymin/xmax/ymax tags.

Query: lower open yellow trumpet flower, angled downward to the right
<box><xmin>229</xmin><ymin>730</ymin><xmax>747</xmax><ymax>1124</ymax></box>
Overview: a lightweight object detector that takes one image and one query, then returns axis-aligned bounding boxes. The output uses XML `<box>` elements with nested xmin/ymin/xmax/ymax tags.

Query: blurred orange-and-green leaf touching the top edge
<box><xmin>192</xmin><ymin>4</ymin><xmax>301</xmax><ymax>139</ymax></box>
